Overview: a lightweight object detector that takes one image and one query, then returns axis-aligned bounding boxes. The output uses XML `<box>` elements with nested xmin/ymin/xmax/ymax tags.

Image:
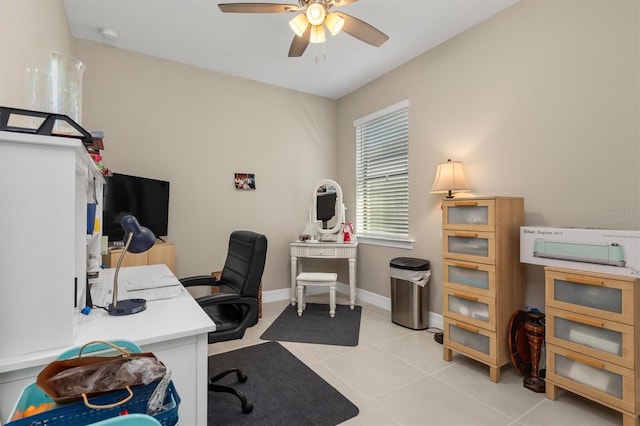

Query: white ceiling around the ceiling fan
<box><xmin>64</xmin><ymin>0</ymin><xmax>519</xmax><ymax>99</ymax></box>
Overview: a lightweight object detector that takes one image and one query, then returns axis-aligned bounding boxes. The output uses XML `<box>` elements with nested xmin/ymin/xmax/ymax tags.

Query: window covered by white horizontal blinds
<box><xmin>353</xmin><ymin>101</ymin><xmax>410</xmax><ymax>246</ymax></box>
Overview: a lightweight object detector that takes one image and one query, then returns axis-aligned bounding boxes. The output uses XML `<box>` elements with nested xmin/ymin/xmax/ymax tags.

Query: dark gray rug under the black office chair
<box><xmin>207</xmin><ymin>342</ymin><xmax>359</xmax><ymax>426</ymax></box>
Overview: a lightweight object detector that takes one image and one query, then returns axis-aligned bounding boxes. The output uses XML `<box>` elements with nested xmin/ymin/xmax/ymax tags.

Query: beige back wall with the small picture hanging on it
<box><xmin>74</xmin><ymin>40</ymin><xmax>336</xmax><ymax>290</ymax></box>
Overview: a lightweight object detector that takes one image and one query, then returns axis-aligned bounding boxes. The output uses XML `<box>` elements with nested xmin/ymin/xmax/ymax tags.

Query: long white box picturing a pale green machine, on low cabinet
<box><xmin>520</xmin><ymin>226</ymin><xmax>640</xmax><ymax>278</ymax></box>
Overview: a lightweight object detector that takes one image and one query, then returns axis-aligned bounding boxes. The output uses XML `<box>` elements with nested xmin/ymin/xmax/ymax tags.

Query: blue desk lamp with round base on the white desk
<box><xmin>108</xmin><ymin>215</ymin><xmax>156</xmax><ymax>316</ymax></box>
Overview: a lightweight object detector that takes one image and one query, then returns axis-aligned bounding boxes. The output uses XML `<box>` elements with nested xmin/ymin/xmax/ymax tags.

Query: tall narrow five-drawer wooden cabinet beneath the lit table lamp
<box><xmin>442</xmin><ymin>197</ymin><xmax>524</xmax><ymax>382</ymax></box>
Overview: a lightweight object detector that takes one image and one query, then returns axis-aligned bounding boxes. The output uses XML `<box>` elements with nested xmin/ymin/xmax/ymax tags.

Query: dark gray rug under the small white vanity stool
<box><xmin>260</xmin><ymin>303</ymin><xmax>362</xmax><ymax>346</ymax></box>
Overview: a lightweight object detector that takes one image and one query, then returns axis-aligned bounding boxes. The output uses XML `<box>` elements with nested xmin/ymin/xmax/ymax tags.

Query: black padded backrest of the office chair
<box><xmin>220</xmin><ymin>231</ymin><xmax>267</xmax><ymax>298</ymax></box>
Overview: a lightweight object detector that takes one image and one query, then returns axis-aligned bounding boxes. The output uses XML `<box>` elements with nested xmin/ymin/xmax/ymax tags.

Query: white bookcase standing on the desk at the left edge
<box><xmin>0</xmin><ymin>131</ymin><xmax>104</xmax><ymax>360</ymax></box>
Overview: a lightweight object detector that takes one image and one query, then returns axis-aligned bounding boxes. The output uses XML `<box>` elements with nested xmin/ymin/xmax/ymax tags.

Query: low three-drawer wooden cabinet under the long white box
<box><xmin>545</xmin><ymin>267</ymin><xmax>640</xmax><ymax>426</ymax></box>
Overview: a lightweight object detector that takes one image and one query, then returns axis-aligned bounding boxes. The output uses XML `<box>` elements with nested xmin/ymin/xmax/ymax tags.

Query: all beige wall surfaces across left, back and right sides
<box><xmin>0</xmin><ymin>0</ymin><xmax>640</xmax><ymax>312</ymax></box>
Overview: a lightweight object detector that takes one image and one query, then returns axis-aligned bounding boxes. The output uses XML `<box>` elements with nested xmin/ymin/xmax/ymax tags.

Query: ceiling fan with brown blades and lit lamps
<box><xmin>218</xmin><ymin>0</ymin><xmax>389</xmax><ymax>57</ymax></box>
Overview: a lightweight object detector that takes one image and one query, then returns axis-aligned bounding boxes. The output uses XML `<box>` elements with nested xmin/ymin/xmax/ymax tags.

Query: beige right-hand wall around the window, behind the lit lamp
<box><xmin>338</xmin><ymin>0</ymin><xmax>640</xmax><ymax>313</ymax></box>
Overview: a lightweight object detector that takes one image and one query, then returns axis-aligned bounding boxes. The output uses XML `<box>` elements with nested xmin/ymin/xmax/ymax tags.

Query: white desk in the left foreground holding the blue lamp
<box><xmin>0</xmin><ymin>265</ymin><xmax>215</xmax><ymax>425</ymax></box>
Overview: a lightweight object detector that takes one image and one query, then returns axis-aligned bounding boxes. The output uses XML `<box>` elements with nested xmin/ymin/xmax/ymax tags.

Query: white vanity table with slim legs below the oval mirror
<box><xmin>289</xmin><ymin>241</ymin><xmax>358</xmax><ymax>309</ymax></box>
